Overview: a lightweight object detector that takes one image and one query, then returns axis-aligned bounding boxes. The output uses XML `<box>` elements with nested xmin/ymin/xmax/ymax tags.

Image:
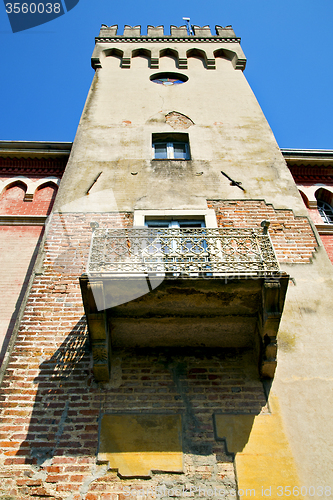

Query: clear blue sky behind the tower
<box><xmin>0</xmin><ymin>0</ymin><xmax>333</xmax><ymax>149</ymax></box>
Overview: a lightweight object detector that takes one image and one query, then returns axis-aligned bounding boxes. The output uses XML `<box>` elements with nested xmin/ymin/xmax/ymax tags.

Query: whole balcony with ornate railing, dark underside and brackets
<box><xmin>80</xmin><ymin>227</ymin><xmax>289</xmax><ymax>380</ymax></box>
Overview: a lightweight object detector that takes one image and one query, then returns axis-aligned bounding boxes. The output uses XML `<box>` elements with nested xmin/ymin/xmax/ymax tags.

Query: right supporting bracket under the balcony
<box><xmin>258</xmin><ymin>274</ymin><xmax>289</xmax><ymax>378</ymax></box>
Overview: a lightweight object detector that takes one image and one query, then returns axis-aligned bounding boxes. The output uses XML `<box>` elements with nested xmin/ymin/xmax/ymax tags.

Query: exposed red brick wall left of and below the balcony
<box><xmin>0</xmin><ymin>214</ymin><xmax>267</xmax><ymax>500</ymax></box>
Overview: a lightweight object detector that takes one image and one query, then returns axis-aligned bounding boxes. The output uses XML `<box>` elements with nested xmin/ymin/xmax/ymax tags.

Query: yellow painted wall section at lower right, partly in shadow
<box><xmin>215</xmin><ymin>397</ymin><xmax>300</xmax><ymax>500</ymax></box>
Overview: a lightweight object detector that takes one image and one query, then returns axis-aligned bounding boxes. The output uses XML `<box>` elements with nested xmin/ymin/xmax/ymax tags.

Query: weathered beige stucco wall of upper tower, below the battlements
<box><xmin>53</xmin><ymin>49</ymin><xmax>306</xmax><ymax>214</ymax></box>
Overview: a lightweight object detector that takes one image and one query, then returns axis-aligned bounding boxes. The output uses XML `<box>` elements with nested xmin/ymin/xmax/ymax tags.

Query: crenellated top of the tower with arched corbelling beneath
<box><xmin>91</xmin><ymin>24</ymin><xmax>246</xmax><ymax>71</ymax></box>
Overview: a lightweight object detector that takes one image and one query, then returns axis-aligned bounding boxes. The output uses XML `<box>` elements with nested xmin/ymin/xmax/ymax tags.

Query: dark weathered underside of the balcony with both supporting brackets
<box><xmin>80</xmin><ymin>275</ymin><xmax>289</xmax><ymax>380</ymax></box>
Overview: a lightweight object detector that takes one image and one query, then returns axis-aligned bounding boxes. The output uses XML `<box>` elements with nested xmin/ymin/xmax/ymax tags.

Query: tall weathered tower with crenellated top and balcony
<box><xmin>3</xmin><ymin>22</ymin><xmax>333</xmax><ymax>500</ymax></box>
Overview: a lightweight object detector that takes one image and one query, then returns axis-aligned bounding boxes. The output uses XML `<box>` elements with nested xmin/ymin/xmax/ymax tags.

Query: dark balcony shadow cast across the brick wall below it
<box><xmin>19</xmin><ymin>316</ymin><xmax>266</xmax><ymax>477</ymax></box>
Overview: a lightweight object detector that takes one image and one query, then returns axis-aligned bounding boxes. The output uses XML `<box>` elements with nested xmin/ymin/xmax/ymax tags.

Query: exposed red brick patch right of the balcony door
<box><xmin>208</xmin><ymin>200</ymin><xmax>317</xmax><ymax>263</ymax></box>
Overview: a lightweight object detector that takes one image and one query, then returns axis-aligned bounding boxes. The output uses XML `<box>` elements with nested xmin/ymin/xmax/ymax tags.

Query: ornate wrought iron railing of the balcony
<box><xmin>87</xmin><ymin>223</ymin><xmax>280</xmax><ymax>277</ymax></box>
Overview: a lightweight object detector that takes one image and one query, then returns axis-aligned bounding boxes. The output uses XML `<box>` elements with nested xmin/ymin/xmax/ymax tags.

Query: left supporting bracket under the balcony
<box><xmin>80</xmin><ymin>275</ymin><xmax>111</xmax><ymax>382</ymax></box>
